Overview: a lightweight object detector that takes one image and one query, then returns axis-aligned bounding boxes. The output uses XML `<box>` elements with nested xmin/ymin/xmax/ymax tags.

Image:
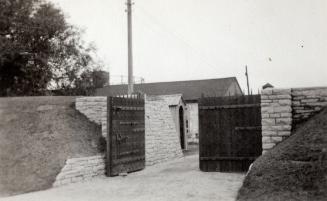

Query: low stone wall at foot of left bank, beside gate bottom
<box><xmin>53</xmin><ymin>155</ymin><xmax>105</xmax><ymax>187</ymax></box>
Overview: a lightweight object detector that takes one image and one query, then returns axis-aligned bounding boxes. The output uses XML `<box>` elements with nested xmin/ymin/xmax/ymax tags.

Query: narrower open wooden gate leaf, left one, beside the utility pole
<box><xmin>106</xmin><ymin>96</ymin><xmax>145</xmax><ymax>176</ymax></box>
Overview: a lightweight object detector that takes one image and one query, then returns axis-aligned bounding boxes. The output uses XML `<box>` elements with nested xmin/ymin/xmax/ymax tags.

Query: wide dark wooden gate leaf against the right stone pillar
<box><xmin>199</xmin><ymin>95</ymin><xmax>262</xmax><ymax>172</ymax></box>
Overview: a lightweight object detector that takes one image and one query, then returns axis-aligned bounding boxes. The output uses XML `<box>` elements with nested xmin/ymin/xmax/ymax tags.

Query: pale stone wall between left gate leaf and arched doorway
<box><xmin>145</xmin><ymin>96</ymin><xmax>183</xmax><ymax>165</ymax></box>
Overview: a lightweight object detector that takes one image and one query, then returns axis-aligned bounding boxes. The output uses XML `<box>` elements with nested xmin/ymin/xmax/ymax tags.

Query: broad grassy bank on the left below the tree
<box><xmin>0</xmin><ymin>97</ymin><xmax>101</xmax><ymax>196</ymax></box>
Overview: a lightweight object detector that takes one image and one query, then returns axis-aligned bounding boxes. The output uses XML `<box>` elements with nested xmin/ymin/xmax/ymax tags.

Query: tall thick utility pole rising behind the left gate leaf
<box><xmin>126</xmin><ymin>0</ymin><xmax>134</xmax><ymax>95</ymax></box>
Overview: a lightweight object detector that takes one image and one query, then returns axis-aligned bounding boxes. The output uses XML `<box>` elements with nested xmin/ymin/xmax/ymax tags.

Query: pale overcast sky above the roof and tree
<box><xmin>50</xmin><ymin>0</ymin><xmax>327</xmax><ymax>92</ymax></box>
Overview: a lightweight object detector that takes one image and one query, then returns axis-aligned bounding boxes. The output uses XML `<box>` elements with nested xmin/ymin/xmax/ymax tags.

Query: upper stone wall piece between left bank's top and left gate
<box><xmin>75</xmin><ymin>96</ymin><xmax>107</xmax><ymax>138</ymax></box>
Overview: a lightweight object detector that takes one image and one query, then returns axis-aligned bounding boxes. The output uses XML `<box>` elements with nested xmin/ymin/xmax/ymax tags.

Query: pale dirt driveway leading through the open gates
<box><xmin>0</xmin><ymin>155</ymin><xmax>244</xmax><ymax>201</ymax></box>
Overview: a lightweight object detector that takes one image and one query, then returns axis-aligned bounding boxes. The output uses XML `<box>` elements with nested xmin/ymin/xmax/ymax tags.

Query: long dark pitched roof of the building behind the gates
<box><xmin>96</xmin><ymin>77</ymin><xmax>241</xmax><ymax>101</ymax></box>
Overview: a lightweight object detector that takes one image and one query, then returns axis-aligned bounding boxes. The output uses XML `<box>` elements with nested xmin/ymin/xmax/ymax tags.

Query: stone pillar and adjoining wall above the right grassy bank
<box><xmin>261</xmin><ymin>87</ymin><xmax>327</xmax><ymax>153</ymax></box>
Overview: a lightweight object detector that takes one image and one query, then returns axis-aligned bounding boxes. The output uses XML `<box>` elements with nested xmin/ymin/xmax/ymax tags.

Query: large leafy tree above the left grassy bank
<box><xmin>0</xmin><ymin>0</ymin><xmax>101</xmax><ymax>96</ymax></box>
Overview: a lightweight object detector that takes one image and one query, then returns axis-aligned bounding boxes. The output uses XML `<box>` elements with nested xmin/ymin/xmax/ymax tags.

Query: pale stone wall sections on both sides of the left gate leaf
<box><xmin>53</xmin><ymin>96</ymin><xmax>183</xmax><ymax>187</ymax></box>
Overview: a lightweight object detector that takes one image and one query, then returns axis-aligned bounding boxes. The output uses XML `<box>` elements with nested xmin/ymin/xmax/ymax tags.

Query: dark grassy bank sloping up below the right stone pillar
<box><xmin>238</xmin><ymin>109</ymin><xmax>327</xmax><ymax>201</ymax></box>
